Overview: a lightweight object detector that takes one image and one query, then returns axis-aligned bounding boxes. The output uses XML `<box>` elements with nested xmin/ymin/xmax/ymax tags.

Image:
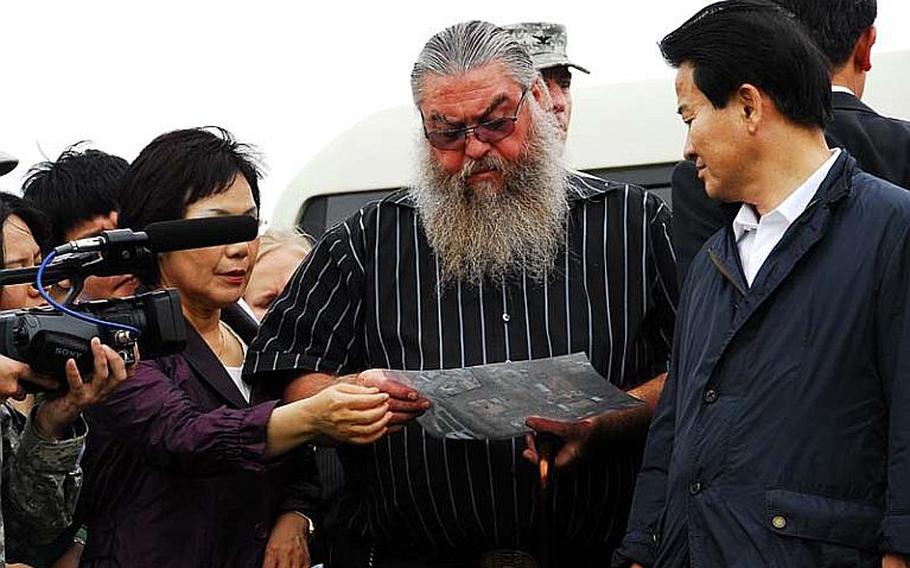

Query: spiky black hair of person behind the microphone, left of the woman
<box><xmin>22</xmin><ymin>142</ymin><xmax>129</xmax><ymax>246</ymax></box>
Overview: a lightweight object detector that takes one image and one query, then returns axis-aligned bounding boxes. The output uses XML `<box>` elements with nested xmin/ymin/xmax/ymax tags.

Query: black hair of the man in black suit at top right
<box><xmin>774</xmin><ymin>0</ymin><xmax>878</xmax><ymax>68</ymax></box>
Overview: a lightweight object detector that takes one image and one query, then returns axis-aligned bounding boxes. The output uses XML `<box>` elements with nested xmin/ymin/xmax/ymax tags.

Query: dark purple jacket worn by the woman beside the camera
<box><xmin>82</xmin><ymin>308</ymin><xmax>315</xmax><ymax>568</ymax></box>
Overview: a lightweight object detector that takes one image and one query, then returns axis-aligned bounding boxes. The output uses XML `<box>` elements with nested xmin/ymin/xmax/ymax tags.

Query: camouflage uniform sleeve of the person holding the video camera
<box><xmin>0</xmin><ymin>405</ymin><xmax>88</xmax><ymax>560</ymax></box>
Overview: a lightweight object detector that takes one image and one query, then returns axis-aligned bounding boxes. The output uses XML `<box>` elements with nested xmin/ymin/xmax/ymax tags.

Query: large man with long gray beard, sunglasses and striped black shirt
<box><xmin>246</xmin><ymin>22</ymin><xmax>677</xmax><ymax>567</ymax></box>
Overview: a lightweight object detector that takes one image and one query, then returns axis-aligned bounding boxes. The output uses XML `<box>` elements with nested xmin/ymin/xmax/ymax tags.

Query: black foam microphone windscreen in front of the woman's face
<box><xmin>144</xmin><ymin>215</ymin><xmax>259</xmax><ymax>252</ymax></box>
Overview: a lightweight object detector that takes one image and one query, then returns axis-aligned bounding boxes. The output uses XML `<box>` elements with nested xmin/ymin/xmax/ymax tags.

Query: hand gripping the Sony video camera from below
<box><xmin>35</xmin><ymin>337</ymin><xmax>138</xmax><ymax>439</ymax></box>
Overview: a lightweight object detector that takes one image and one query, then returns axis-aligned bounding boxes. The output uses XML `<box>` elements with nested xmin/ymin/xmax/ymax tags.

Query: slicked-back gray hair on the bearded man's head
<box><xmin>411</xmin><ymin>20</ymin><xmax>538</xmax><ymax>106</ymax></box>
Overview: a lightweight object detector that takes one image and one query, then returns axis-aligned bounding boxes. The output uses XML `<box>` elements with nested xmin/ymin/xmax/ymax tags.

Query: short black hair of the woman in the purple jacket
<box><xmin>118</xmin><ymin>126</ymin><xmax>261</xmax><ymax>284</ymax></box>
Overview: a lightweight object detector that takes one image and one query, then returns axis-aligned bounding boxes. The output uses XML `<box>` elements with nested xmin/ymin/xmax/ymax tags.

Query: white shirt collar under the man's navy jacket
<box><xmin>733</xmin><ymin>148</ymin><xmax>840</xmax><ymax>286</ymax></box>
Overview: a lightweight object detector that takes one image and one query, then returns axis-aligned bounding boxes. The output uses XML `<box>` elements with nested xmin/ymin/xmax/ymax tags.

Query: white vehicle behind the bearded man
<box><xmin>272</xmin><ymin>51</ymin><xmax>910</xmax><ymax>238</ymax></box>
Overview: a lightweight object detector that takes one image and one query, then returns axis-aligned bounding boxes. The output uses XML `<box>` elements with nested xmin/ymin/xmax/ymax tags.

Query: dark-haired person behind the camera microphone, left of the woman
<box><xmin>22</xmin><ymin>144</ymin><xmax>138</xmax><ymax>300</ymax></box>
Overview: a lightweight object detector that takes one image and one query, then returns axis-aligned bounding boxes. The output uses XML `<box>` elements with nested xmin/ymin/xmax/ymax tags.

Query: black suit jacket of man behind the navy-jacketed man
<box><xmin>672</xmin><ymin>92</ymin><xmax>910</xmax><ymax>282</ymax></box>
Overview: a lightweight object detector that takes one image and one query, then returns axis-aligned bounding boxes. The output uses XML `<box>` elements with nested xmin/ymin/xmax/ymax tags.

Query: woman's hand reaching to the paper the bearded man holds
<box><xmin>306</xmin><ymin>383</ymin><xmax>392</xmax><ymax>444</ymax></box>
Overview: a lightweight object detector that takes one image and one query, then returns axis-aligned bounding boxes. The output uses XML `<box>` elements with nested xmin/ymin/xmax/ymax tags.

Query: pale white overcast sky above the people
<box><xmin>0</xmin><ymin>0</ymin><xmax>910</xmax><ymax>218</ymax></box>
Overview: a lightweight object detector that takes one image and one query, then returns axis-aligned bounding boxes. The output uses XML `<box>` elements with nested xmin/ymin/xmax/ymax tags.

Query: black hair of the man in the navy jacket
<box><xmin>660</xmin><ymin>0</ymin><xmax>831</xmax><ymax>128</ymax></box>
